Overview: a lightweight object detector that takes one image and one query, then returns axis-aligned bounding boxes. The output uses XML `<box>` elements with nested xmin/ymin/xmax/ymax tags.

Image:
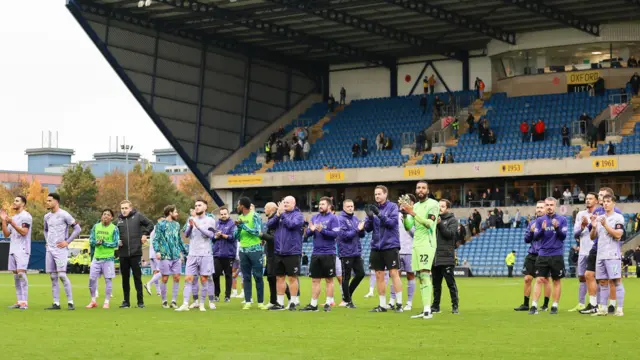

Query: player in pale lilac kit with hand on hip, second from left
<box><xmin>44</xmin><ymin>193</ymin><xmax>81</xmax><ymax>310</ymax></box>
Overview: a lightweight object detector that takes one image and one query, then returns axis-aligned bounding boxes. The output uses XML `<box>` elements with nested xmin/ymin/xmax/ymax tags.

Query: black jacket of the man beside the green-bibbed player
<box><xmin>116</xmin><ymin>209</ymin><xmax>153</xmax><ymax>257</ymax></box>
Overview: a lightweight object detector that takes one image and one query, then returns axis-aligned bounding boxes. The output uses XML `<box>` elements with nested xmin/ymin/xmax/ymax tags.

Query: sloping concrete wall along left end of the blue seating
<box><xmin>211</xmin><ymin>94</ymin><xmax>322</xmax><ymax>176</ymax></box>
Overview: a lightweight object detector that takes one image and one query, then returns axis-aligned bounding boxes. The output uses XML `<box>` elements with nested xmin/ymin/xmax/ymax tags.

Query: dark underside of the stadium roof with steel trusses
<box><xmin>87</xmin><ymin>0</ymin><xmax>640</xmax><ymax>64</ymax></box>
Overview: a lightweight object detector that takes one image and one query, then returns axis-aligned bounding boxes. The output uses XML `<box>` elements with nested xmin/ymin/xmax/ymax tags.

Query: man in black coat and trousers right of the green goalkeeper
<box><xmin>431</xmin><ymin>199</ymin><xmax>458</xmax><ymax>314</ymax></box>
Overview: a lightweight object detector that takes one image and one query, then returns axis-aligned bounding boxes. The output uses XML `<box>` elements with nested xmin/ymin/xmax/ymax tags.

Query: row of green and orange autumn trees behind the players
<box><xmin>0</xmin><ymin>164</ymin><xmax>215</xmax><ymax>240</ymax></box>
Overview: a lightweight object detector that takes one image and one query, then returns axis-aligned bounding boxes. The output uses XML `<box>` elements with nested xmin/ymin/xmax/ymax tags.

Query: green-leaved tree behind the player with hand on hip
<box><xmin>58</xmin><ymin>164</ymin><xmax>100</xmax><ymax>232</ymax></box>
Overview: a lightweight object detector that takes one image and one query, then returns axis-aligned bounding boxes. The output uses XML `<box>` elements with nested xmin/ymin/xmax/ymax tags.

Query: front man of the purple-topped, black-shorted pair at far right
<box><xmin>529</xmin><ymin>197</ymin><xmax>569</xmax><ymax>315</ymax></box>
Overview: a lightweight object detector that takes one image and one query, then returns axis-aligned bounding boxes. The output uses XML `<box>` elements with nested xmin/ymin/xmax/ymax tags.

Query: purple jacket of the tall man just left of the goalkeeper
<box><xmin>364</xmin><ymin>200</ymin><xmax>400</xmax><ymax>250</ymax></box>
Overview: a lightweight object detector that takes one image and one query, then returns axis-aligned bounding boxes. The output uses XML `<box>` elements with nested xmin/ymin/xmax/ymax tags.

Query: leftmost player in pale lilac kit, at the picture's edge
<box><xmin>0</xmin><ymin>195</ymin><xmax>33</xmax><ymax>310</ymax></box>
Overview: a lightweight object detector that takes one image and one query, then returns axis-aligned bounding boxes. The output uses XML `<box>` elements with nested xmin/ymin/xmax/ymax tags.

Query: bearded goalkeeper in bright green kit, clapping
<box><xmin>402</xmin><ymin>181</ymin><xmax>440</xmax><ymax>320</ymax></box>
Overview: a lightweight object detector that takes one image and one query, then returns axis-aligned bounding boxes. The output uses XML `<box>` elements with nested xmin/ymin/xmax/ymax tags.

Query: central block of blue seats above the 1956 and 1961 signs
<box><xmin>267</xmin><ymin>92</ymin><xmax>470</xmax><ymax>172</ymax></box>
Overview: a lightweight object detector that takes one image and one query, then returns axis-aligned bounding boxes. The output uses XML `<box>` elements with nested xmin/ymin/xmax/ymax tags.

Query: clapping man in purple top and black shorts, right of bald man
<box><xmin>300</xmin><ymin>197</ymin><xmax>340</xmax><ymax>311</ymax></box>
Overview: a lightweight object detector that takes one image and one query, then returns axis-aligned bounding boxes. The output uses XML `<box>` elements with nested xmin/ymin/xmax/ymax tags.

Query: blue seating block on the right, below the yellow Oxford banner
<box><xmin>447</xmin><ymin>92</ymin><xmax>609</xmax><ymax>163</ymax></box>
